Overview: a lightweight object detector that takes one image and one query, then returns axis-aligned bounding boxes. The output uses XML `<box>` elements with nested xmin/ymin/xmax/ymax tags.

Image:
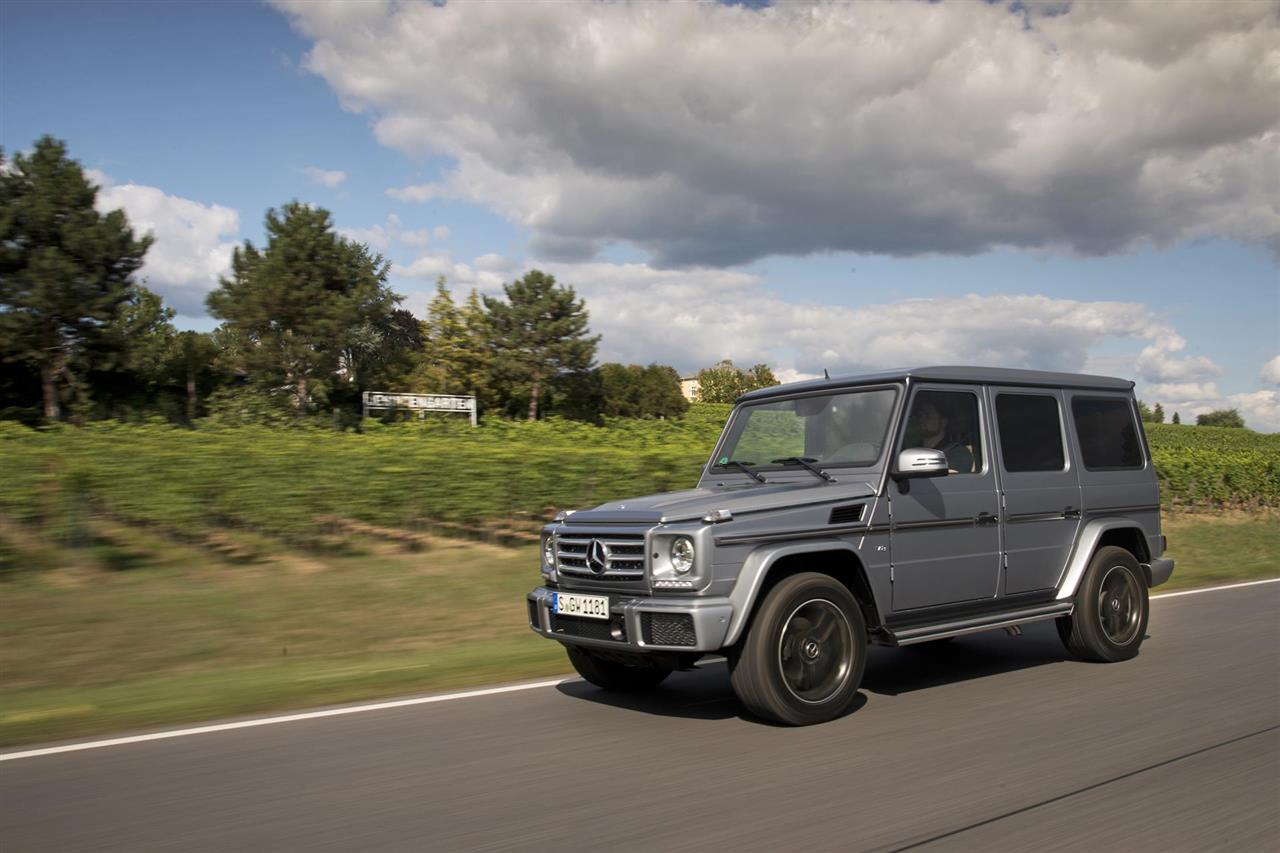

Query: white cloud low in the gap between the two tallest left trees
<box><xmin>88</xmin><ymin>170</ymin><xmax>239</xmax><ymax>318</ymax></box>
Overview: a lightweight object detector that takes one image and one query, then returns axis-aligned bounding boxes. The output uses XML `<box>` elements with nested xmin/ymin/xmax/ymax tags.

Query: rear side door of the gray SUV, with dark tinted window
<box><xmin>987</xmin><ymin>386</ymin><xmax>1080</xmax><ymax>596</ymax></box>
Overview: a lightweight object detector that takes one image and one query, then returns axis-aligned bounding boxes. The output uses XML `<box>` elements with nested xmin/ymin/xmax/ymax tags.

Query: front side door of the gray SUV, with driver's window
<box><xmin>888</xmin><ymin>386</ymin><xmax>1000</xmax><ymax>612</ymax></box>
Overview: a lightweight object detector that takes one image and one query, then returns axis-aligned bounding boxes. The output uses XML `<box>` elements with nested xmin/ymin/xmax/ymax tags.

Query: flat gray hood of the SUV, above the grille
<box><xmin>567</xmin><ymin>475</ymin><xmax>878</xmax><ymax>524</ymax></box>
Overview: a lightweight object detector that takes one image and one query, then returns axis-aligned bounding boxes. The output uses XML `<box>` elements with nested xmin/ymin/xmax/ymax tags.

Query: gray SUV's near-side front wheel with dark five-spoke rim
<box><xmin>730</xmin><ymin>573</ymin><xmax>867</xmax><ymax>726</ymax></box>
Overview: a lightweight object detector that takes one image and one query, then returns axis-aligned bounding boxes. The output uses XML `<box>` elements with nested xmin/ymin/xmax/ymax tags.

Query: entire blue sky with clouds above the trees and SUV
<box><xmin>0</xmin><ymin>0</ymin><xmax>1280</xmax><ymax>429</ymax></box>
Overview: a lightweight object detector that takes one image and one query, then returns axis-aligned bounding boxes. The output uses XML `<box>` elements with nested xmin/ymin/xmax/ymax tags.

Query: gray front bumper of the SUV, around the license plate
<box><xmin>526</xmin><ymin>587</ymin><xmax>733</xmax><ymax>652</ymax></box>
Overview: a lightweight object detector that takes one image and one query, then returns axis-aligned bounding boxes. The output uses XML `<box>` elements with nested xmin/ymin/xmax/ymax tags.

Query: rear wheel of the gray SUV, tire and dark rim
<box><xmin>1056</xmin><ymin>546</ymin><xmax>1151</xmax><ymax>663</ymax></box>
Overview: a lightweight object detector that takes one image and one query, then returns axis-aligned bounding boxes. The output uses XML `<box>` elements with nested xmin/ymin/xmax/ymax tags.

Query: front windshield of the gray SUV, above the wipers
<box><xmin>716</xmin><ymin>388</ymin><xmax>897</xmax><ymax>467</ymax></box>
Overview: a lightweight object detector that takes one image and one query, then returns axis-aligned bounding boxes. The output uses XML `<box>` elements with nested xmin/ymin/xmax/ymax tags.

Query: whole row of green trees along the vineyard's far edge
<box><xmin>0</xmin><ymin>136</ymin><xmax>776</xmax><ymax>424</ymax></box>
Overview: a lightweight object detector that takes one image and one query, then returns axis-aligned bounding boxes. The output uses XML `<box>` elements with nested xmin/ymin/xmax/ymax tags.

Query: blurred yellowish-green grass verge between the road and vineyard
<box><xmin>0</xmin><ymin>512</ymin><xmax>1280</xmax><ymax>745</ymax></box>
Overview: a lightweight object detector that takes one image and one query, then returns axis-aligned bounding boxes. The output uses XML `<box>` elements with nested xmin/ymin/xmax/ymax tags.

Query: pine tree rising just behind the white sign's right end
<box><xmin>484</xmin><ymin>269</ymin><xmax>600</xmax><ymax>420</ymax></box>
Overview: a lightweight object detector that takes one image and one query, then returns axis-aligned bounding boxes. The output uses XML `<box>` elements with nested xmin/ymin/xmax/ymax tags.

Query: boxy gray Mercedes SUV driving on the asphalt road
<box><xmin>529</xmin><ymin>368</ymin><xmax>1174</xmax><ymax>725</ymax></box>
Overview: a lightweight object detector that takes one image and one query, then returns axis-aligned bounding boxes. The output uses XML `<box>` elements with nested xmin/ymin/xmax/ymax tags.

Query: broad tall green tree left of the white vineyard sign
<box><xmin>207</xmin><ymin>201</ymin><xmax>401</xmax><ymax>414</ymax></box>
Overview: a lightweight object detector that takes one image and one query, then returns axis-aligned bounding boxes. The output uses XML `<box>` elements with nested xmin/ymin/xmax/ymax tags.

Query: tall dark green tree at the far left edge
<box><xmin>0</xmin><ymin>136</ymin><xmax>151</xmax><ymax>420</ymax></box>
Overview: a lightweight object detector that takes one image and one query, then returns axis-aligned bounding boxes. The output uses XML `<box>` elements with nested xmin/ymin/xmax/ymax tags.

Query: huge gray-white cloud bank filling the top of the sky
<box><xmin>276</xmin><ymin>0</ymin><xmax>1280</xmax><ymax>266</ymax></box>
